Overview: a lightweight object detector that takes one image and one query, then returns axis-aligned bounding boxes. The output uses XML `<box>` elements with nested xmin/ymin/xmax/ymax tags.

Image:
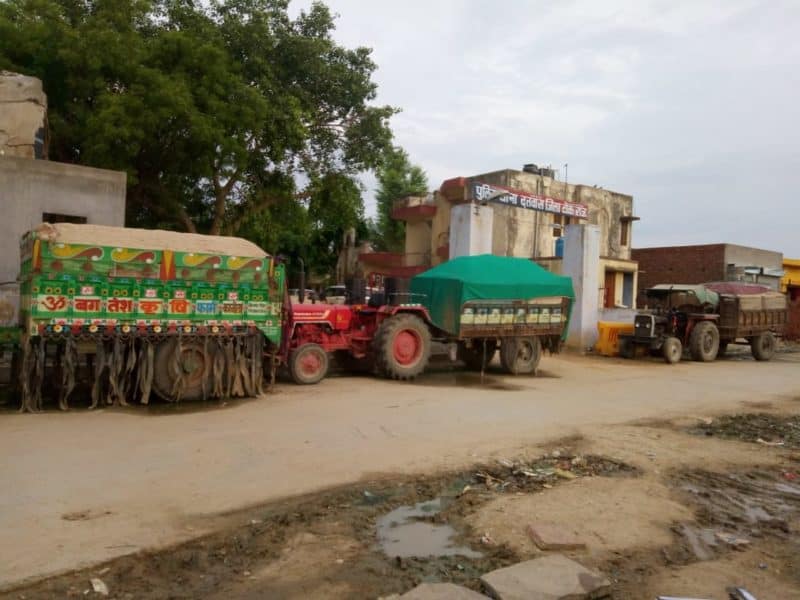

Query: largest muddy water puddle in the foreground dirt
<box><xmin>377</xmin><ymin>498</ymin><xmax>483</xmax><ymax>558</ymax></box>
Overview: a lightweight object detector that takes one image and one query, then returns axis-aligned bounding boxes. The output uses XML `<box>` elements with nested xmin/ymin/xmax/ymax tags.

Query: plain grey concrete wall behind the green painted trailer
<box><xmin>0</xmin><ymin>156</ymin><xmax>126</xmax><ymax>281</ymax></box>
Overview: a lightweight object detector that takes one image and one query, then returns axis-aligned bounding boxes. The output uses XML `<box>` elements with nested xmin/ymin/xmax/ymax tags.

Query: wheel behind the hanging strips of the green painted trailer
<box><xmin>153</xmin><ymin>338</ymin><xmax>216</xmax><ymax>402</ymax></box>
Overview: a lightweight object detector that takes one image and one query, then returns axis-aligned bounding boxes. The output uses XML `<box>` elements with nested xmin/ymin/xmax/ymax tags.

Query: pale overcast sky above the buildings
<box><xmin>293</xmin><ymin>0</ymin><xmax>800</xmax><ymax>258</ymax></box>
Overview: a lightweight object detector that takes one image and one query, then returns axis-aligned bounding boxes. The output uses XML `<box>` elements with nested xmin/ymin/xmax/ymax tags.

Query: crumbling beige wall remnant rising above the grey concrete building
<box><xmin>0</xmin><ymin>71</ymin><xmax>47</xmax><ymax>159</ymax></box>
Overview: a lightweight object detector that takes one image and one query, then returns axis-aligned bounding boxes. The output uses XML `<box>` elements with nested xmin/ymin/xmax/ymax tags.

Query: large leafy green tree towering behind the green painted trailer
<box><xmin>0</xmin><ymin>0</ymin><xmax>396</xmax><ymax>234</ymax></box>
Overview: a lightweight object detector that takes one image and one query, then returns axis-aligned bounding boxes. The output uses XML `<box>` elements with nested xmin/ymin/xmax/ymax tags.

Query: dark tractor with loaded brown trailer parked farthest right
<box><xmin>619</xmin><ymin>284</ymin><xmax>789</xmax><ymax>364</ymax></box>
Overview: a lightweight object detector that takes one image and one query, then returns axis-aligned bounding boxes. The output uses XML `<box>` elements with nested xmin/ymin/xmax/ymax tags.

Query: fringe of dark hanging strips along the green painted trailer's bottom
<box><xmin>20</xmin><ymin>331</ymin><xmax>268</xmax><ymax>412</ymax></box>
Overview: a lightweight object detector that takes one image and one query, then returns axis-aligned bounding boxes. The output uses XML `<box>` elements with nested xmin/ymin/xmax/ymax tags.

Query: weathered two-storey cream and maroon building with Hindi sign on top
<box><xmin>360</xmin><ymin>165</ymin><xmax>638</xmax><ymax>308</ymax></box>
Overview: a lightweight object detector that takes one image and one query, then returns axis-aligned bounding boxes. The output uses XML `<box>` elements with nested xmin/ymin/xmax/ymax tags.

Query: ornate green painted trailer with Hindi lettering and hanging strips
<box><xmin>19</xmin><ymin>224</ymin><xmax>285</xmax><ymax>410</ymax></box>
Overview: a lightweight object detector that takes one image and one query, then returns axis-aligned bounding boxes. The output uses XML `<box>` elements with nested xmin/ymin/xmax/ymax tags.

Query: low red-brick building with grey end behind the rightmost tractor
<box><xmin>631</xmin><ymin>244</ymin><xmax>783</xmax><ymax>301</ymax></box>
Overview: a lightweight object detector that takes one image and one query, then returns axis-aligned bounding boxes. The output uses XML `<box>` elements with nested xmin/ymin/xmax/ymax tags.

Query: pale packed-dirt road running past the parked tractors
<box><xmin>0</xmin><ymin>354</ymin><xmax>800</xmax><ymax>587</ymax></box>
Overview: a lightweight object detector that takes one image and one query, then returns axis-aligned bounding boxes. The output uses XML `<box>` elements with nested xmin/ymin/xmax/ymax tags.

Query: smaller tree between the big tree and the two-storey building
<box><xmin>375</xmin><ymin>147</ymin><xmax>428</xmax><ymax>251</ymax></box>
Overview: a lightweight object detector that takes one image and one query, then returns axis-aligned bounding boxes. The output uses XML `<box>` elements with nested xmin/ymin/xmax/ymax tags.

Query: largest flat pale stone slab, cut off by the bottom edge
<box><xmin>481</xmin><ymin>554</ymin><xmax>611</xmax><ymax>600</ymax></box>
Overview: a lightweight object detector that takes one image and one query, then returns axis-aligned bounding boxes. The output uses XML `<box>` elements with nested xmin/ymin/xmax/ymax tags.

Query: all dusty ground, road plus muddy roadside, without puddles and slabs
<box><xmin>0</xmin><ymin>346</ymin><xmax>800</xmax><ymax>598</ymax></box>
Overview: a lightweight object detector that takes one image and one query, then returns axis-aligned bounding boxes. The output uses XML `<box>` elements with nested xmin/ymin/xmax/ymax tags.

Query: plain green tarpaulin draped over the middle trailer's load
<box><xmin>410</xmin><ymin>254</ymin><xmax>575</xmax><ymax>334</ymax></box>
